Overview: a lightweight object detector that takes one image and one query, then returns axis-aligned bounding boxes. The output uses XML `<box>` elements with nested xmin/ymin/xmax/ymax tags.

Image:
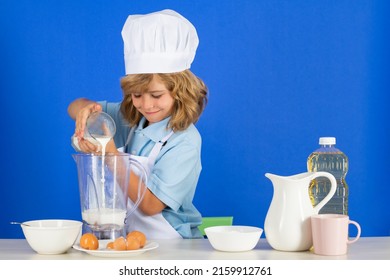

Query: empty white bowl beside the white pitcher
<box><xmin>204</xmin><ymin>226</ymin><xmax>263</xmax><ymax>252</ymax></box>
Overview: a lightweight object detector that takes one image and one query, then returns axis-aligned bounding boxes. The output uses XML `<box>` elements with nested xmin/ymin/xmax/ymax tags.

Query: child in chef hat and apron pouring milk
<box><xmin>68</xmin><ymin>10</ymin><xmax>207</xmax><ymax>239</ymax></box>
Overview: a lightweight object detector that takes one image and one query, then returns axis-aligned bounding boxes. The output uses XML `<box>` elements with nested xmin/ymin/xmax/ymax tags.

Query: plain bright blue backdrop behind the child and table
<box><xmin>0</xmin><ymin>0</ymin><xmax>390</xmax><ymax>238</ymax></box>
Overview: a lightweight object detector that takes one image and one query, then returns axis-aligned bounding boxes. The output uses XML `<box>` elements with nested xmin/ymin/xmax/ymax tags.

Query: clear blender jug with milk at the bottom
<box><xmin>73</xmin><ymin>154</ymin><xmax>147</xmax><ymax>239</ymax></box>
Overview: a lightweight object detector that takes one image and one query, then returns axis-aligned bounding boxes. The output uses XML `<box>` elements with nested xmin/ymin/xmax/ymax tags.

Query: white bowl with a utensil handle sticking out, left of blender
<box><xmin>21</xmin><ymin>220</ymin><xmax>82</xmax><ymax>254</ymax></box>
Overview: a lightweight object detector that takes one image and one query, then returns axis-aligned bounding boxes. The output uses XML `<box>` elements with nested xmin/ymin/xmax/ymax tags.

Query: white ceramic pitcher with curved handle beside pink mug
<box><xmin>264</xmin><ymin>172</ymin><xmax>337</xmax><ymax>251</ymax></box>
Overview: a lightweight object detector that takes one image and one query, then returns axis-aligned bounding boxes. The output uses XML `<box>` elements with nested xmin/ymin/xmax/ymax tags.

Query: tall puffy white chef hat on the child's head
<box><xmin>122</xmin><ymin>10</ymin><xmax>199</xmax><ymax>74</ymax></box>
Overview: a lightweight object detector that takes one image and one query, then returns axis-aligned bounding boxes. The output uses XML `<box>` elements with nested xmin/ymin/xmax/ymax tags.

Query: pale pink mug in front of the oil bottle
<box><xmin>311</xmin><ymin>214</ymin><xmax>361</xmax><ymax>256</ymax></box>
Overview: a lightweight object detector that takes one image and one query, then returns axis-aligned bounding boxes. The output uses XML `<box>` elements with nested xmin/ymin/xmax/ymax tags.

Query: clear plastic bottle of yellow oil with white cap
<box><xmin>307</xmin><ymin>137</ymin><xmax>348</xmax><ymax>215</ymax></box>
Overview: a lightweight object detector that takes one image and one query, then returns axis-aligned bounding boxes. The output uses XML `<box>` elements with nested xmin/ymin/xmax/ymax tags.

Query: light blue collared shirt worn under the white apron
<box><xmin>99</xmin><ymin>101</ymin><xmax>202</xmax><ymax>238</ymax></box>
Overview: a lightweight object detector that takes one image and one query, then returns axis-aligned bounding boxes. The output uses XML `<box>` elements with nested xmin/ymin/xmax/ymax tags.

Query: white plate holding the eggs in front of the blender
<box><xmin>73</xmin><ymin>240</ymin><xmax>158</xmax><ymax>258</ymax></box>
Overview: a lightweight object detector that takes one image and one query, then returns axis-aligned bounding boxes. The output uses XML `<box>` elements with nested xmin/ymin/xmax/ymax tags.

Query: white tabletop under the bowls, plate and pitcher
<box><xmin>0</xmin><ymin>236</ymin><xmax>390</xmax><ymax>260</ymax></box>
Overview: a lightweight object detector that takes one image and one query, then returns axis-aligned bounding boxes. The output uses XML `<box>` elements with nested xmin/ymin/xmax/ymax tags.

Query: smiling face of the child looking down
<box><xmin>131</xmin><ymin>76</ymin><xmax>174</xmax><ymax>124</ymax></box>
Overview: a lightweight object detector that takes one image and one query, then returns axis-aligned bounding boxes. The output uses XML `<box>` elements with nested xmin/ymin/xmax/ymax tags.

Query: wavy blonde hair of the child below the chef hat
<box><xmin>120</xmin><ymin>70</ymin><xmax>208</xmax><ymax>131</ymax></box>
